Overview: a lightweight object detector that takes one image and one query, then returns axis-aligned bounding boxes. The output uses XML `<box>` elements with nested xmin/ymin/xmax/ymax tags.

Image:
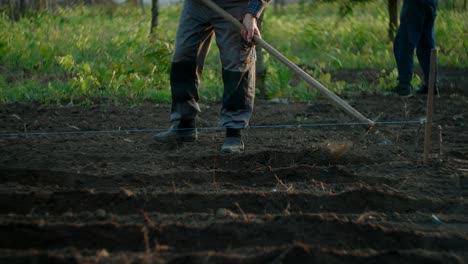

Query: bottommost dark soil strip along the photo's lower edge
<box><xmin>0</xmin><ymin>248</ymin><xmax>463</xmax><ymax>264</ymax></box>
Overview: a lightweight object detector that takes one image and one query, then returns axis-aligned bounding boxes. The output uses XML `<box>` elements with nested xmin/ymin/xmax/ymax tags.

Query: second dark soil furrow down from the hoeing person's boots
<box><xmin>0</xmin><ymin>188</ymin><xmax>460</xmax><ymax>214</ymax></box>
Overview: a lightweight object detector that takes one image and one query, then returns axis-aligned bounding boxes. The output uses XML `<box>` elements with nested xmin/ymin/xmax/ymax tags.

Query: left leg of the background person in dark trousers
<box><xmin>394</xmin><ymin>0</ymin><xmax>424</xmax><ymax>95</ymax></box>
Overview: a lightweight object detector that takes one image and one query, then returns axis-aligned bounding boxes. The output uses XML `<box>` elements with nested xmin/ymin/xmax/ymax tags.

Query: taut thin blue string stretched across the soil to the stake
<box><xmin>0</xmin><ymin>119</ymin><xmax>426</xmax><ymax>137</ymax></box>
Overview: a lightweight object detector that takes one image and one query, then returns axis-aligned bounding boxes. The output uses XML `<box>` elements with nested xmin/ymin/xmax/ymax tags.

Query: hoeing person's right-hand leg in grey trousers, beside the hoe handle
<box><xmin>214</xmin><ymin>0</ymin><xmax>256</xmax><ymax>152</ymax></box>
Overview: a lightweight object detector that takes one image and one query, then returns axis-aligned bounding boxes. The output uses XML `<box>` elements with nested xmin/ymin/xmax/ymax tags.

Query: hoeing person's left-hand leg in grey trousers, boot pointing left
<box><xmin>153</xmin><ymin>0</ymin><xmax>214</xmax><ymax>142</ymax></box>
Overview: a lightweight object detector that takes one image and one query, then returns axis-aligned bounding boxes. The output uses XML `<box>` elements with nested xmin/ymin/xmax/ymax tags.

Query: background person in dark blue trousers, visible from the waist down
<box><xmin>393</xmin><ymin>0</ymin><xmax>438</xmax><ymax>97</ymax></box>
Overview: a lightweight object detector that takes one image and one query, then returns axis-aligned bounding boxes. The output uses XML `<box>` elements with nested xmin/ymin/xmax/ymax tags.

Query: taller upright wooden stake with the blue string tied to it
<box><xmin>424</xmin><ymin>49</ymin><xmax>437</xmax><ymax>164</ymax></box>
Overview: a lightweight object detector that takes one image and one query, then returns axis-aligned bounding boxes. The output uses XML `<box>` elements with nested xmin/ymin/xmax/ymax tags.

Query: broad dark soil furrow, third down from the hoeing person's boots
<box><xmin>0</xmin><ymin>215</ymin><xmax>468</xmax><ymax>253</ymax></box>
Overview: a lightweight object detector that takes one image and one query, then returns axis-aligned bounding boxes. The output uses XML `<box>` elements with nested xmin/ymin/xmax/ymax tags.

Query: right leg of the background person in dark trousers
<box><xmin>416</xmin><ymin>1</ymin><xmax>437</xmax><ymax>93</ymax></box>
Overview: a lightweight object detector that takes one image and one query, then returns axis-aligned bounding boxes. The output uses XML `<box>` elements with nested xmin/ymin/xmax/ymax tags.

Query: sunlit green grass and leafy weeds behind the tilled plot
<box><xmin>0</xmin><ymin>1</ymin><xmax>468</xmax><ymax>104</ymax></box>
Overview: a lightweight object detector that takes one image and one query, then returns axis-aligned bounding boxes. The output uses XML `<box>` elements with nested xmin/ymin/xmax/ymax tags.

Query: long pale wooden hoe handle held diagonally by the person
<box><xmin>200</xmin><ymin>0</ymin><xmax>375</xmax><ymax>128</ymax></box>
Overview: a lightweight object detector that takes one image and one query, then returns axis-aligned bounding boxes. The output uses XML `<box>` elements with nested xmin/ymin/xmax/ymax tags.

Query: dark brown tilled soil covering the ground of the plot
<box><xmin>0</xmin><ymin>69</ymin><xmax>468</xmax><ymax>263</ymax></box>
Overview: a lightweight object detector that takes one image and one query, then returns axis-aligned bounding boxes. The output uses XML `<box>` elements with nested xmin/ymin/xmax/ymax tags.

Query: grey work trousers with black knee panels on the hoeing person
<box><xmin>170</xmin><ymin>0</ymin><xmax>256</xmax><ymax>128</ymax></box>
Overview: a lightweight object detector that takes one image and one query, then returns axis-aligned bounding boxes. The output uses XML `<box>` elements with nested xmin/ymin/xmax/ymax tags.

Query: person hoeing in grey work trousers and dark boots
<box><xmin>153</xmin><ymin>0</ymin><xmax>270</xmax><ymax>153</ymax></box>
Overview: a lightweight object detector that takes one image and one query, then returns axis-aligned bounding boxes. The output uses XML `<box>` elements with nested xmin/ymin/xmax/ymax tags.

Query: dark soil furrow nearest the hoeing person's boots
<box><xmin>0</xmin><ymin>165</ymin><xmax>399</xmax><ymax>188</ymax></box>
